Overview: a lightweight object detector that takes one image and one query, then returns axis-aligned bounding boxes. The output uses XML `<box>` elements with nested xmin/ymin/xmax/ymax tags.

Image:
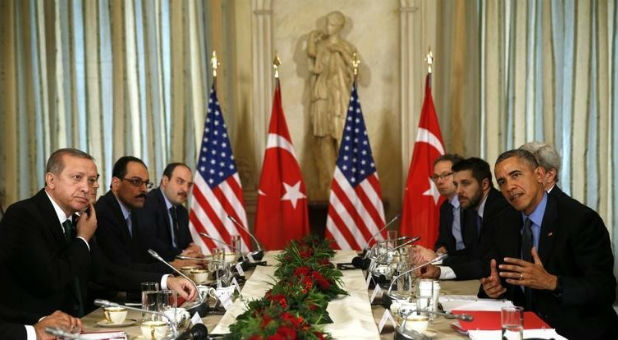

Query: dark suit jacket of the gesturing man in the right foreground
<box><xmin>481</xmin><ymin>193</ymin><xmax>618</xmax><ymax>339</ymax></box>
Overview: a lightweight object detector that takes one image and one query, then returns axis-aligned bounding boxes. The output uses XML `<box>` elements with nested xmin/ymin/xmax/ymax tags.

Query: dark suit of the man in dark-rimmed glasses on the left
<box><xmin>95</xmin><ymin>190</ymin><xmax>171</xmax><ymax>274</ymax></box>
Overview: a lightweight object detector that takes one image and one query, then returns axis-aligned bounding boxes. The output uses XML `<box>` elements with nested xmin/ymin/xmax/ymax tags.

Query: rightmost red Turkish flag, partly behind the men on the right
<box><xmin>399</xmin><ymin>74</ymin><xmax>444</xmax><ymax>249</ymax></box>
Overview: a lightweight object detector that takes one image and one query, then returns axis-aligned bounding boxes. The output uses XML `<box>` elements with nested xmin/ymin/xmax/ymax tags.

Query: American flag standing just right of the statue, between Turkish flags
<box><xmin>326</xmin><ymin>82</ymin><xmax>385</xmax><ymax>249</ymax></box>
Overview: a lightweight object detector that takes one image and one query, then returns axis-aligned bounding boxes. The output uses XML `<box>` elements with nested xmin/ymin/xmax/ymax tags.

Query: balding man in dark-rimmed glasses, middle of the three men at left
<box><xmin>95</xmin><ymin>156</ymin><xmax>192</xmax><ymax>273</ymax></box>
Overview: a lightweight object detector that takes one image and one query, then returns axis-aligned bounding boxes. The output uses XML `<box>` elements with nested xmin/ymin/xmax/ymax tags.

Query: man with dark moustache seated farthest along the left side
<box><xmin>135</xmin><ymin>163</ymin><xmax>202</xmax><ymax>261</ymax></box>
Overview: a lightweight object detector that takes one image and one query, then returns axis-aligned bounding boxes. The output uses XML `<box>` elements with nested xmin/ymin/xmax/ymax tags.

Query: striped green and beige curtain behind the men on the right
<box><xmin>434</xmin><ymin>0</ymin><xmax>618</xmax><ymax>273</ymax></box>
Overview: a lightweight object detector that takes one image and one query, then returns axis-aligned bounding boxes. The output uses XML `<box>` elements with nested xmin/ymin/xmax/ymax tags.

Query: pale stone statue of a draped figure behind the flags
<box><xmin>307</xmin><ymin>11</ymin><xmax>356</xmax><ymax>201</ymax></box>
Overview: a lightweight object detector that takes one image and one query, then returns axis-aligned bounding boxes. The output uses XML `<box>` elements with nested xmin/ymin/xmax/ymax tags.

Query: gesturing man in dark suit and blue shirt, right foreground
<box><xmin>481</xmin><ymin>150</ymin><xmax>618</xmax><ymax>339</ymax></box>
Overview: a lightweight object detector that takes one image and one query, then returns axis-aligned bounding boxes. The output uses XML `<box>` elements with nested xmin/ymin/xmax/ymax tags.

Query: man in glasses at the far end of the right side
<box><xmin>431</xmin><ymin>154</ymin><xmax>466</xmax><ymax>254</ymax></box>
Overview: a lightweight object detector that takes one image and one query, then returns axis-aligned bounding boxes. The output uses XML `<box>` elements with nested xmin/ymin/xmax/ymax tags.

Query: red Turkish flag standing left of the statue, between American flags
<box><xmin>255</xmin><ymin>79</ymin><xmax>309</xmax><ymax>250</ymax></box>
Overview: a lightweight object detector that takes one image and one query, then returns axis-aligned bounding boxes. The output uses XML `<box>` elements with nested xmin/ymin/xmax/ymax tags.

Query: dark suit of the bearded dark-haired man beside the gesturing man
<box><xmin>443</xmin><ymin>187</ymin><xmax>519</xmax><ymax>280</ymax></box>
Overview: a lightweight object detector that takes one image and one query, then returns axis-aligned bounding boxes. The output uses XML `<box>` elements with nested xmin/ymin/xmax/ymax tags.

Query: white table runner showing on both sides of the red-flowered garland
<box><xmin>212</xmin><ymin>251</ymin><xmax>380</xmax><ymax>340</ymax></box>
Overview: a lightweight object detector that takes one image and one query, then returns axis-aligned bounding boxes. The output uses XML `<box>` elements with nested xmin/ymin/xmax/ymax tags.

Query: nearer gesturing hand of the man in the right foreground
<box><xmin>500</xmin><ymin>247</ymin><xmax>558</xmax><ymax>290</ymax></box>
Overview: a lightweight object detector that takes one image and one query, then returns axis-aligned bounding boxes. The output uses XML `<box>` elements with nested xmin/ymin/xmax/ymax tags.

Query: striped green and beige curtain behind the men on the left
<box><xmin>0</xmin><ymin>0</ymin><xmax>210</xmax><ymax>208</ymax></box>
